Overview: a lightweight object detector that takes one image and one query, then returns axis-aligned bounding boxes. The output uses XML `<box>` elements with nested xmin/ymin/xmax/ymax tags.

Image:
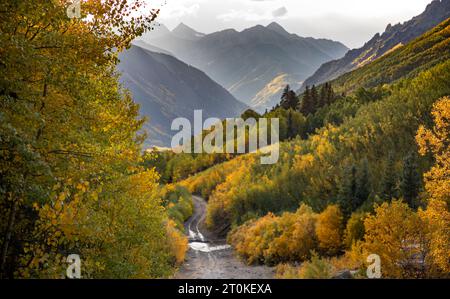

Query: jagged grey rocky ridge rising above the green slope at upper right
<box><xmin>302</xmin><ymin>0</ymin><xmax>450</xmax><ymax>89</ymax></box>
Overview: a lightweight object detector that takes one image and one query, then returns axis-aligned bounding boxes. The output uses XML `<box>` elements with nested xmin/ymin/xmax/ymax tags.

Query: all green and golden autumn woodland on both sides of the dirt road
<box><xmin>0</xmin><ymin>0</ymin><xmax>450</xmax><ymax>278</ymax></box>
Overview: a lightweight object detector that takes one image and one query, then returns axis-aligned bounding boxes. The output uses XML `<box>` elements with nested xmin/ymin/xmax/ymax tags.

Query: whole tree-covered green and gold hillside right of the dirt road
<box><xmin>181</xmin><ymin>20</ymin><xmax>450</xmax><ymax>278</ymax></box>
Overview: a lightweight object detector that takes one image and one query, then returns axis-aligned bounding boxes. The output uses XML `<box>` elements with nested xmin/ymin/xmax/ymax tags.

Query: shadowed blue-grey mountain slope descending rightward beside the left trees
<box><xmin>118</xmin><ymin>46</ymin><xmax>246</xmax><ymax>146</ymax></box>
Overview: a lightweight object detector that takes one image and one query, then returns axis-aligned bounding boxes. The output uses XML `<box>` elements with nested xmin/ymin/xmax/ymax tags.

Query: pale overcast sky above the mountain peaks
<box><xmin>146</xmin><ymin>0</ymin><xmax>431</xmax><ymax>48</ymax></box>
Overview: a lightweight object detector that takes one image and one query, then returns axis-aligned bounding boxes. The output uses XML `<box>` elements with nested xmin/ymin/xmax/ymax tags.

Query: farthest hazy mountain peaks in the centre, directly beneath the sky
<box><xmin>138</xmin><ymin>23</ymin><xmax>348</xmax><ymax>110</ymax></box>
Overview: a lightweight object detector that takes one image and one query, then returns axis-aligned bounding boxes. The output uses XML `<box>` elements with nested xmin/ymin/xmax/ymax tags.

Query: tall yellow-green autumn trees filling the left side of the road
<box><xmin>0</xmin><ymin>0</ymin><xmax>192</xmax><ymax>278</ymax></box>
